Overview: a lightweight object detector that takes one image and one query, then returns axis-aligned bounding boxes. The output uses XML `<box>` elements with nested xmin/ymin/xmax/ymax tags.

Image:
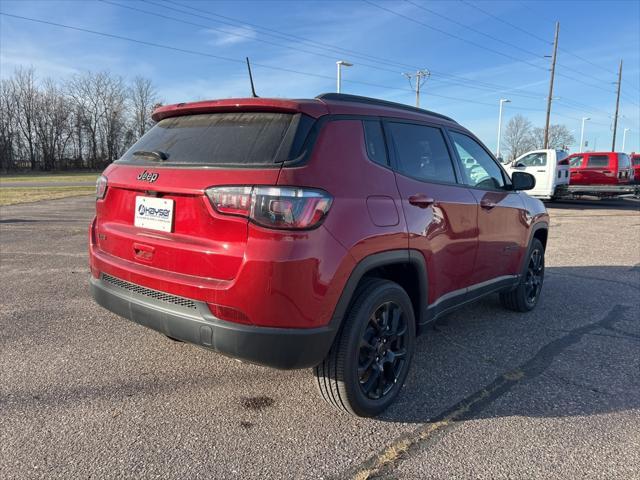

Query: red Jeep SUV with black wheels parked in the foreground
<box><xmin>89</xmin><ymin>94</ymin><xmax>548</xmax><ymax>416</ymax></box>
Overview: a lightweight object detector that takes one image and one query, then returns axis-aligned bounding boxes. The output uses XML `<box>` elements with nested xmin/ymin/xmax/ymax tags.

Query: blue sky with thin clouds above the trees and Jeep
<box><xmin>0</xmin><ymin>0</ymin><xmax>640</xmax><ymax>151</ymax></box>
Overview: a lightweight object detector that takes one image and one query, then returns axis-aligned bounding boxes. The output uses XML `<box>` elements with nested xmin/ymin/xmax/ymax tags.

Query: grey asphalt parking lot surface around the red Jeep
<box><xmin>0</xmin><ymin>197</ymin><xmax>640</xmax><ymax>479</ymax></box>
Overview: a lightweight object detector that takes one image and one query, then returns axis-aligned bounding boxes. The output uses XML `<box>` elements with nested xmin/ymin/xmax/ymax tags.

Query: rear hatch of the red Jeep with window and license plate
<box><xmin>94</xmin><ymin>104</ymin><xmax>314</xmax><ymax>284</ymax></box>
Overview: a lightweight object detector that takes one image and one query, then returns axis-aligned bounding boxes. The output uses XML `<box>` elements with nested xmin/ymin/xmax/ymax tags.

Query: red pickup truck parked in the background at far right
<box><xmin>569</xmin><ymin>152</ymin><xmax>637</xmax><ymax>197</ymax></box>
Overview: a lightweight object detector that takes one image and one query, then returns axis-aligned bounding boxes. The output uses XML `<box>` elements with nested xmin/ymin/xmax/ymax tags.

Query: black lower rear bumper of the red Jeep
<box><xmin>90</xmin><ymin>277</ymin><xmax>335</xmax><ymax>369</ymax></box>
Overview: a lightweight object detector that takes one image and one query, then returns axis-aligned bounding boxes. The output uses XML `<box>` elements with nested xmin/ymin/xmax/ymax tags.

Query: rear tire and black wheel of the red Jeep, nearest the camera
<box><xmin>314</xmin><ymin>278</ymin><xmax>416</xmax><ymax>417</ymax></box>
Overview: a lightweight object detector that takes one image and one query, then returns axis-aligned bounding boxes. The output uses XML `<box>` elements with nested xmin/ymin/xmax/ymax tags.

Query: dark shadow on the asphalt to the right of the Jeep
<box><xmin>380</xmin><ymin>266</ymin><xmax>640</xmax><ymax>424</ymax></box>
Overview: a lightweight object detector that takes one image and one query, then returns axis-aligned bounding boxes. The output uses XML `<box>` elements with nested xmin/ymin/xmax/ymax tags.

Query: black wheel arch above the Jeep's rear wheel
<box><xmin>331</xmin><ymin>250</ymin><xmax>428</xmax><ymax>331</ymax></box>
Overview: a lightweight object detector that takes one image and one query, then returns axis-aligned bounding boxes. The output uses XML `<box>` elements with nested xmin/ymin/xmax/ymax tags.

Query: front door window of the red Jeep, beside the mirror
<box><xmin>451</xmin><ymin>132</ymin><xmax>505</xmax><ymax>189</ymax></box>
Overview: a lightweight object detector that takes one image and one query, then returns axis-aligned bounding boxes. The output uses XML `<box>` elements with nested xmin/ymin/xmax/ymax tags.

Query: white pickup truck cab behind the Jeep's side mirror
<box><xmin>505</xmin><ymin>149</ymin><xmax>569</xmax><ymax>200</ymax></box>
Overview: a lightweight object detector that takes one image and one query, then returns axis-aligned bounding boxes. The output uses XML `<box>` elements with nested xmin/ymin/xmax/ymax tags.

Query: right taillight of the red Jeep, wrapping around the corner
<box><xmin>206</xmin><ymin>186</ymin><xmax>333</xmax><ymax>230</ymax></box>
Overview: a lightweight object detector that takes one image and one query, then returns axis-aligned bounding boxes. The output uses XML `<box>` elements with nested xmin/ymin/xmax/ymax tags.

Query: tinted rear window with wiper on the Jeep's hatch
<box><xmin>121</xmin><ymin>112</ymin><xmax>294</xmax><ymax>165</ymax></box>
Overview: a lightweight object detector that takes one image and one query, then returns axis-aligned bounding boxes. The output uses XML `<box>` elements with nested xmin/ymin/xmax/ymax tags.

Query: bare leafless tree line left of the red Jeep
<box><xmin>0</xmin><ymin>68</ymin><xmax>160</xmax><ymax>171</ymax></box>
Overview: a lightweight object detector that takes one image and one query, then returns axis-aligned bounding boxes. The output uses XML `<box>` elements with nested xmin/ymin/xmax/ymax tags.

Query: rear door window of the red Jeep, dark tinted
<box><xmin>389</xmin><ymin>122</ymin><xmax>456</xmax><ymax>183</ymax></box>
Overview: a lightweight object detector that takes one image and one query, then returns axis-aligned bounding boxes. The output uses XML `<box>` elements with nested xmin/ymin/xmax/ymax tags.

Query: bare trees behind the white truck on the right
<box><xmin>502</xmin><ymin>115</ymin><xmax>575</xmax><ymax>160</ymax></box>
